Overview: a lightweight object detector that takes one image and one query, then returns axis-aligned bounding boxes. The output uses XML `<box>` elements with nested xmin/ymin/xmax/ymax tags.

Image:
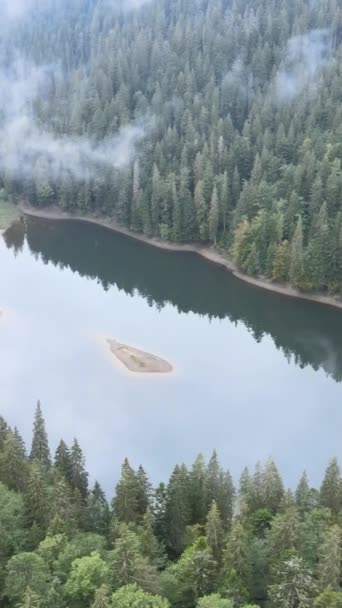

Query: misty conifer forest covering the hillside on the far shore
<box><xmin>0</xmin><ymin>0</ymin><xmax>342</xmax><ymax>293</ymax></box>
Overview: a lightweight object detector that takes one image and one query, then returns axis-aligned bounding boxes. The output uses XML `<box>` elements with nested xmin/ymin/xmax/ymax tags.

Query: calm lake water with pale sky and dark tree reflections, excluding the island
<box><xmin>0</xmin><ymin>219</ymin><xmax>342</xmax><ymax>493</ymax></box>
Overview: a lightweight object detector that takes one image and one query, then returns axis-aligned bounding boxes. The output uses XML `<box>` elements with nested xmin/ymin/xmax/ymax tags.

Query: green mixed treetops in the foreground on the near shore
<box><xmin>0</xmin><ymin>403</ymin><xmax>342</xmax><ymax>608</ymax></box>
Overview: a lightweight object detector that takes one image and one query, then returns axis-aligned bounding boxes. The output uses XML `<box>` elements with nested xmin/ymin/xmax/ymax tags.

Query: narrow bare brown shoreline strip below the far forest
<box><xmin>18</xmin><ymin>204</ymin><xmax>342</xmax><ymax>309</ymax></box>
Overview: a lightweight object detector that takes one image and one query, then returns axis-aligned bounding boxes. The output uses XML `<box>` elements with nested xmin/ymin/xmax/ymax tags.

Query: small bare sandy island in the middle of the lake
<box><xmin>107</xmin><ymin>340</ymin><xmax>173</xmax><ymax>374</ymax></box>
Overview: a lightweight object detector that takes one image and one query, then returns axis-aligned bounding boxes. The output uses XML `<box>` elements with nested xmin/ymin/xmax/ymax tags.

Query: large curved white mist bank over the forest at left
<box><xmin>0</xmin><ymin>61</ymin><xmax>152</xmax><ymax>181</ymax></box>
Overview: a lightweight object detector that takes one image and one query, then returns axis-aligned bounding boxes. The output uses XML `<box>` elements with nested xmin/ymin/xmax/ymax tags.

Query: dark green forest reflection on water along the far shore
<box><xmin>4</xmin><ymin>218</ymin><xmax>342</xmax><ymax>381</ymax></box>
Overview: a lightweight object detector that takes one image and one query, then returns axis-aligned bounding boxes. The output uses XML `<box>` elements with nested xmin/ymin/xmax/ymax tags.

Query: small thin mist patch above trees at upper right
<box><xmin>275</xmin><ymin>29</ymin><xmax>331</xmax><ymax>101</ymax></box>
